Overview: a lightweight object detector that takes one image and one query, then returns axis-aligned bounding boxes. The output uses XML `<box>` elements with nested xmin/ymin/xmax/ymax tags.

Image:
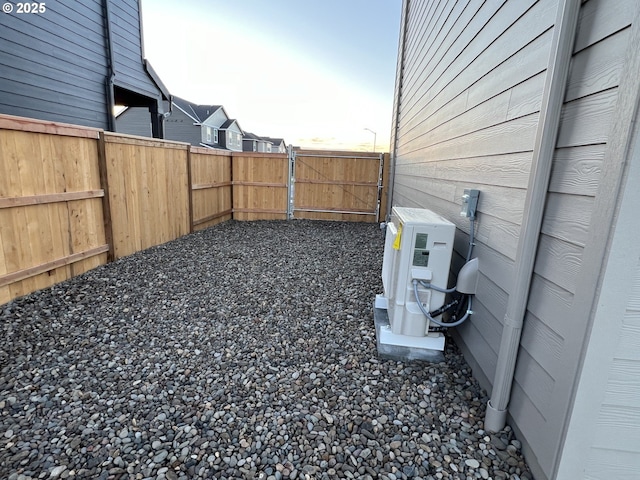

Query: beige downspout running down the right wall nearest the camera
<box><xmin>484</xmin><ymin>0</ymin><xmax>581</xmax><ymax>432</ymax></box>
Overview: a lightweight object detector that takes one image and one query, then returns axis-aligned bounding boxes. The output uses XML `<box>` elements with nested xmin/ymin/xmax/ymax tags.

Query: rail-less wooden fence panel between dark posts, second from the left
<box><xmin>105</xmin><ymin>134</ymin><xmax>190</xmax><ymax>258</ymax></box>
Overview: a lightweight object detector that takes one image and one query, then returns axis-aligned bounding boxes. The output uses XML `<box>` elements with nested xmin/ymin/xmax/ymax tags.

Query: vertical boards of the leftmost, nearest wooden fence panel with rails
<box><xmin>0</xmin><ymin>127</ymin><xmax>107</xmax><ymax>303</ymax></box>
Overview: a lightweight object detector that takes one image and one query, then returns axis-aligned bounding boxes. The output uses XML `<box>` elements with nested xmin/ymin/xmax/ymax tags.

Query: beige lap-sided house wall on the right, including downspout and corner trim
<box><xmin>390</xmin><ymin>0</ymin><xmax>640</xmax><ymax>480</ymax></box>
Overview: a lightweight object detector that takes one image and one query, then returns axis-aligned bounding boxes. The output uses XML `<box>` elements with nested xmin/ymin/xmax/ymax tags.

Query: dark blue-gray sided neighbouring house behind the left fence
<box><xmin>0</xmin><ymin>0</ymin><xmax>169</xmax><ymax>138</ymax></box>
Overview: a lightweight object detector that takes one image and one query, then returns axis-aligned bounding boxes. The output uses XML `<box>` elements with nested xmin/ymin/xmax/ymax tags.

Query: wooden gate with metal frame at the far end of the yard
<box><xmin>287</xmin><ymin>150</ymin><xmax>384</xmax><ymax>222</ymax></box>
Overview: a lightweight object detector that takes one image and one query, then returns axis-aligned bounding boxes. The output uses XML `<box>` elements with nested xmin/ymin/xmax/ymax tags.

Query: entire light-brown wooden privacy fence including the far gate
<box><xmin>0</xmin><ymin>115</ymin><xmax>388</xmax><ymax>304</ymax></box>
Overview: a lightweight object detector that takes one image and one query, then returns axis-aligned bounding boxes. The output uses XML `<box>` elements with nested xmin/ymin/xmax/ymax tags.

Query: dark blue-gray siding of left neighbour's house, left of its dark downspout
<box><xmin>0</xmin><ymin>1</ymin><xmax>107</xmax><ymax>128</ymax></box>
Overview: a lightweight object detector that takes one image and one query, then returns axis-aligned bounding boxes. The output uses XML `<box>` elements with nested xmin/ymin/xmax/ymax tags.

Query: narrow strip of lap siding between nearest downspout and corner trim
<box><xmin>510</xmin><ymin>0</ymin><xmax>631</xmax><ymax>478</ymax></box>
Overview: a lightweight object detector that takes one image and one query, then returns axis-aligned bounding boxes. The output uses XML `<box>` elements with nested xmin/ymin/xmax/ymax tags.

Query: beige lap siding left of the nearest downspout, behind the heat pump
<box><xmin>393</xmin><ymin>0</ymin><xmax>558</xmax><ymax>458</ymax></box>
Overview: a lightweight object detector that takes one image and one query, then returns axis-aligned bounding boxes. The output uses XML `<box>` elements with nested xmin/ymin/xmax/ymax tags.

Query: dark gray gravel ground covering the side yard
<box><xmin>0</xmin><ymin>220</ymin><xmax>532</xmax><ymax>480</ymax></box>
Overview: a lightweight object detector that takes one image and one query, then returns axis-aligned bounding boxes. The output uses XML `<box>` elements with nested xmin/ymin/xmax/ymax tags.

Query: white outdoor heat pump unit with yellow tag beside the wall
<box><xmin>376</xmin><ymin>207</ymin><xmax>456</xmax><ymax>350</ymax></box>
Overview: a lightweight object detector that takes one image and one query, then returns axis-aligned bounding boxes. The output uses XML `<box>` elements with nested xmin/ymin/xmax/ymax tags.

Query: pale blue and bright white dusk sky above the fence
<box><xmin>142</xmin><ymin>0</ymin><xmax>402</xmax><ymax>151</ymax></box>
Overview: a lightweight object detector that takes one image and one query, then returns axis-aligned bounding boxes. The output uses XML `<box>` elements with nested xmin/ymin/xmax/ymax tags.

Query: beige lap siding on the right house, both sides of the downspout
<box><xmin>392</xmin><ymin>0</ymin><xmax>640</xmax><ymax>479</ymax></box>
